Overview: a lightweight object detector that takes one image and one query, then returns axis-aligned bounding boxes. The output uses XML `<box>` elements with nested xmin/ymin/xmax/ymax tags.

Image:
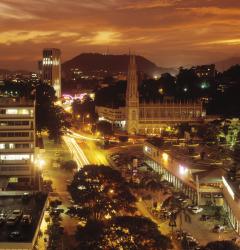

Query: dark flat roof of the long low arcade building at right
<box><xmin>146</xmin><ymin>138</ymin><xmax>232</xmax><ymax>183</ymax></box>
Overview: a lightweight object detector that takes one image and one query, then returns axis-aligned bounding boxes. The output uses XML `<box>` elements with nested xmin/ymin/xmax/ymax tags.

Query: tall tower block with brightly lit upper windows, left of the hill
<box><xmin>42</xmin><ymin>48</ymin><xmax>61</xmax><ymax>98</ymax></box>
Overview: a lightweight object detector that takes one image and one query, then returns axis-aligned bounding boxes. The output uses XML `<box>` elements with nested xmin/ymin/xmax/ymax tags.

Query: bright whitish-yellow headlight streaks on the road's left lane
<box><xmin>63</xmin><ymin>136</ymin><xmax>89</xmax><ymax>170</ymax></box>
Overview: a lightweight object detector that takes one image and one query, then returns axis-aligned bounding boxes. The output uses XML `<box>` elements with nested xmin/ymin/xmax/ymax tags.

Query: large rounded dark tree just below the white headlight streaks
<box><xmin>69</xmin><ymin>165</ymin><xmax>136</xmax><ymax>220</ymax></box>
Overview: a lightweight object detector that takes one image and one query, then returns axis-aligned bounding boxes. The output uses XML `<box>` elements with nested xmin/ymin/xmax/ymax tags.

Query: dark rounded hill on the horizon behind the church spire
<box><xmin>62</xmin><ymin>53</ymin><xmax>174</xmax><ymax>78</ymax></box>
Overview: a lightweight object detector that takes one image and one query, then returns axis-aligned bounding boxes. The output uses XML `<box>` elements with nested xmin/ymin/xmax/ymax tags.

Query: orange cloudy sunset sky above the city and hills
<box><xmin>0</xmin><ymin>0</ymin><xmax>240</xmax><ymax>70</ymax></box>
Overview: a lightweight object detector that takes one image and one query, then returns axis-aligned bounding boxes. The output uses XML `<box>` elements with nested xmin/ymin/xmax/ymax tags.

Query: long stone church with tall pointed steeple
<box><xmin>96</xmin><ymin>55</ymin><xmax>206</xmax><ymax>135</ymax></box>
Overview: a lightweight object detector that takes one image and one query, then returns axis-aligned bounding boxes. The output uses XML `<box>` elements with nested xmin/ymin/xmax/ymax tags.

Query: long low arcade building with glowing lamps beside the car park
<box><xmin>143</xmin><ymin>138</ymin><xmax>230</xmax><ymax>205</ymax></box>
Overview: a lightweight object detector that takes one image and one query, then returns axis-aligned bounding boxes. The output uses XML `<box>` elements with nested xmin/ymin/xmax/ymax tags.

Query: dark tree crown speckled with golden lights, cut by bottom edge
<box><xmin>76</xmin><ymin>216</ymin><xmax>171</xmax><ymax>250</ymax></box>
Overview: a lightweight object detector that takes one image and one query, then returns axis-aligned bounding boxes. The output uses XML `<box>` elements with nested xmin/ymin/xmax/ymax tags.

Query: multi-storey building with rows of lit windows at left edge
<box><xmin>0</xmin><ymin>97</ymin><xmax>35</xmax><ymax>189</ymax></box>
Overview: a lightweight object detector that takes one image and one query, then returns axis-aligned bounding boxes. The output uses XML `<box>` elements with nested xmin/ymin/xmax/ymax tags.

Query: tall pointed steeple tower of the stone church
<box><xmin>126</xmin><ymin>55</ymin><xmax>139</xmax><ymax>134</ymax></box>
